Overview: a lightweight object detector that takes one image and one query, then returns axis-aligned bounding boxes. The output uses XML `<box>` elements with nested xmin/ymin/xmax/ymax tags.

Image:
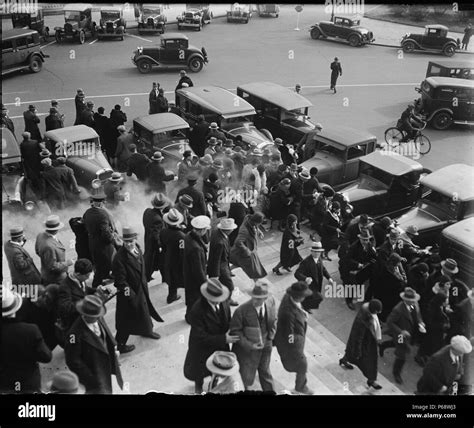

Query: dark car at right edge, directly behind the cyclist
<box><xmin>415</xmin><ymin>77</ymin><xmax>474</xmax><ymax>130</ymax></box>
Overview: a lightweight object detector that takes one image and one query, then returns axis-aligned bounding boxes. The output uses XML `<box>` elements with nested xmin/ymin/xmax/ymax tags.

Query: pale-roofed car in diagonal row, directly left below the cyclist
<box><xmin>301</xmin><ymin>126</ymin><xmax>377</xmax><ymax>189</ymax></box>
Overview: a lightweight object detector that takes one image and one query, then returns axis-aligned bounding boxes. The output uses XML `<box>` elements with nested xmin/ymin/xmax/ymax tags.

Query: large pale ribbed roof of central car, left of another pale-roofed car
<box><xmin>177</xmin><ymin>86</ymin><xmax>257</xmax><ymax>119</ymax></box>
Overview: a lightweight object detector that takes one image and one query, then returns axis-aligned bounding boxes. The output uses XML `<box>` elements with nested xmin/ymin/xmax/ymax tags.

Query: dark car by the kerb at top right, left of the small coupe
<box><xmin>309</xmin><ymin>16</ymin><xmax>375</xmax><ymax>47</ymax></box>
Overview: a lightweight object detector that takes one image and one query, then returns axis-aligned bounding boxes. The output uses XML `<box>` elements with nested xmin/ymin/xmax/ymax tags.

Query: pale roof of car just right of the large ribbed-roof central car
<box><xmin>239</xmin><ymin>82</ymin><xmax>313</xmax><ymax>110</ymax></box>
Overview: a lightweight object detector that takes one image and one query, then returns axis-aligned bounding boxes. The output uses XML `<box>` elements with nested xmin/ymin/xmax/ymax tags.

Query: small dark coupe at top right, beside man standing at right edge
<box><xmin>400</xmin><ymin>25</ymin><xmax>461</xmax><ymax>56</ymax></box>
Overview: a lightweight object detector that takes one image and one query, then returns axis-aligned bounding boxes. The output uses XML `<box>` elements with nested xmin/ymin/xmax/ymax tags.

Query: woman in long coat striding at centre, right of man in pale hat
<box><xmin>230</xmin><ymin>212</ymin><xmax>267</xmax><ymax>279</ymax></box>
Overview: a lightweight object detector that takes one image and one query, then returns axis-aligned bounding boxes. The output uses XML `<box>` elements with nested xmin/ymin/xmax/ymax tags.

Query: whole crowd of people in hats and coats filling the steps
<box><xmin>0</xmin><ymin>72</ymin><xmax>474</xmax><ymax>394</ymax></box>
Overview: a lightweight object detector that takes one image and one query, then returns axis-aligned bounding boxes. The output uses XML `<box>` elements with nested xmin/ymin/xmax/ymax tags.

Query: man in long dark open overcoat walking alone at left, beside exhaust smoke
<box><xmin>112</xmin><ymin>227</ymin><xmax>163</xmax><ymax>353</ymax></box>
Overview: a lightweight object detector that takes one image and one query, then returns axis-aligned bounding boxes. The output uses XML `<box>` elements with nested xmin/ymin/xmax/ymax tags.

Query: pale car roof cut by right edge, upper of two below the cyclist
<box><xmin>420</xmin><ymin>163</ymin><xmax>474</xmax><ymax>201</ymax></box>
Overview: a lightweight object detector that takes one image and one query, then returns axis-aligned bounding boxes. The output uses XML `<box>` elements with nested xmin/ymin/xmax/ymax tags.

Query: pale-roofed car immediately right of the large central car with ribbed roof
<box><xmin>237</xmin><ymin>82</ymin><xmax>315</xmax><ymax>145</ymax></box>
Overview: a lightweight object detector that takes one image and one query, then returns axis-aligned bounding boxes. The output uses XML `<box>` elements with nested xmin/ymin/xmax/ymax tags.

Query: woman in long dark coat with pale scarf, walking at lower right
<box><xmin>339</xmin><ymin>299</ymin><xmax>382</xmax><ymax>389</ymax></box>
